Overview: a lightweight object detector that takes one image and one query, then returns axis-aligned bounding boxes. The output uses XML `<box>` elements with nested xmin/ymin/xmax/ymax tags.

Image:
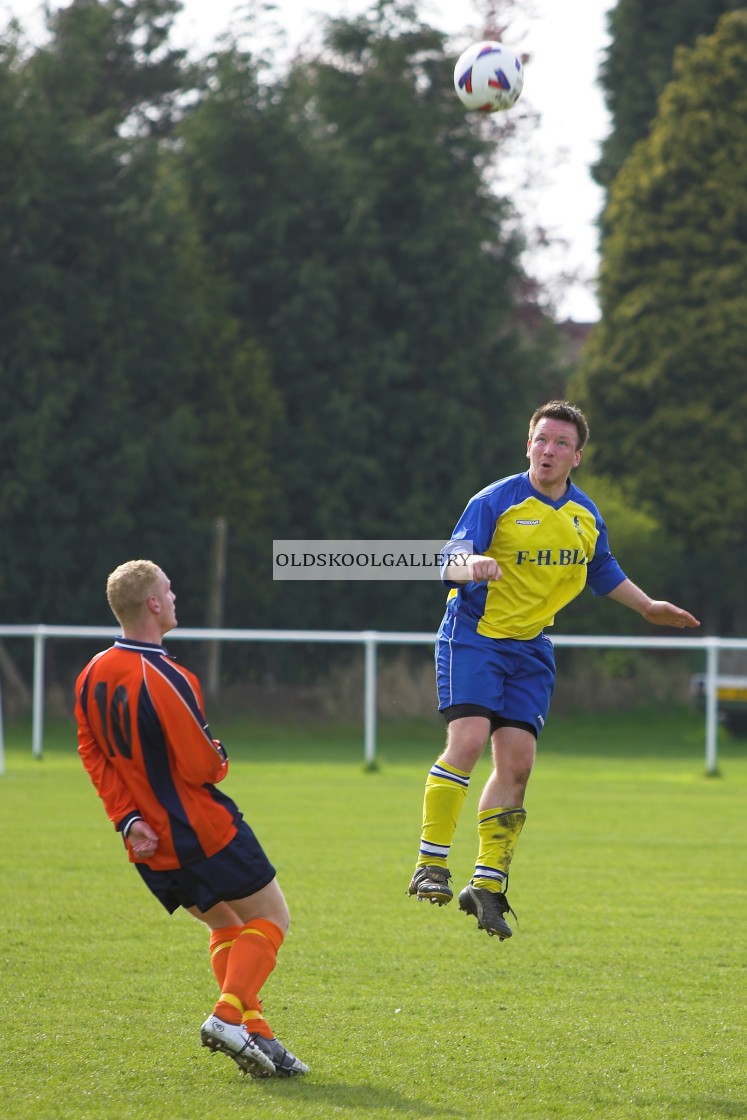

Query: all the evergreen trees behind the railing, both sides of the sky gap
<box><xmin>0</xmin><ymin>0</ymin><xmax>747</xmax><ymax>680</ymax></box>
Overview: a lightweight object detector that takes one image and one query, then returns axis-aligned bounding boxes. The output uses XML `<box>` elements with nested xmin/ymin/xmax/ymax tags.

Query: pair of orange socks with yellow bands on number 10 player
<box><xmin>211</xmin><ymin>917</ymin><xmax>283</xmax><ymax>1038</ymax></box>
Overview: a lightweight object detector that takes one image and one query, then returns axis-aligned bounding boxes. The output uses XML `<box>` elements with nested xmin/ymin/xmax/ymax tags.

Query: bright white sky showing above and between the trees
<box><xmin>0</xmin><ymin>0</ymin><xmax>615</xmax><ymax>320</ymax></box>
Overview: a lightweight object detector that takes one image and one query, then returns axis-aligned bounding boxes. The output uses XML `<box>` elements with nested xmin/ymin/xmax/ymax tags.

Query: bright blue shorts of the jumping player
<box><xmin>436</xmin><ymin>612</ymin><xmax>555</xmax><ymax>735</ymax></box>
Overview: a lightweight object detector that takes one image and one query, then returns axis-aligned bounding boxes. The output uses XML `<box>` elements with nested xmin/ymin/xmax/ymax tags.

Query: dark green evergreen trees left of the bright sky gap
<box><xmin>0</xmin><ymin>0</ymin><xmax>566</xmax><ymax>654</ymax></box>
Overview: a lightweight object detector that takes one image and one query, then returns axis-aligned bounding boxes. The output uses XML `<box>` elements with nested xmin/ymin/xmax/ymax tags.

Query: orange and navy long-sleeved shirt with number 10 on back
<box><xmin>75</xmin><ymin>637</ymin><xmax>241</xmax><ymax>870</ymax></box>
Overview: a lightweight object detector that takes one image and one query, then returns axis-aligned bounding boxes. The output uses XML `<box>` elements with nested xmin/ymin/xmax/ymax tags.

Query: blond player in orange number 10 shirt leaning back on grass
<box><xmin>75</xmin><ymin>560</ymin><xmax>308</xmax><ymax>1077</ymax></box>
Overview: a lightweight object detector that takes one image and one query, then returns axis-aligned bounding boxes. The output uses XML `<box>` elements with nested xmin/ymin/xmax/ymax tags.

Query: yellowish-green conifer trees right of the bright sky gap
<box><xmin>582</xmin><ymin>0</ymin><xmax>747</xmax><ymax>635</ymax></box>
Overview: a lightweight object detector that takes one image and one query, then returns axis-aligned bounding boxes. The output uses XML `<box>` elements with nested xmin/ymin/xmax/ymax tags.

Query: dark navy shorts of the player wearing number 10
<box><xmin>134</xmin><ymin>820</ymin><xmax>276</xmax><ymax>914</ymax></box>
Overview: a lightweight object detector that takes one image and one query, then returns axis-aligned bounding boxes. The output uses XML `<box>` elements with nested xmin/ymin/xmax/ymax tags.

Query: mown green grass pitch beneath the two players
<box><xmin>0</xmin><ymin>710</ymin><xmax>747</xmax><ymax>1120</ymax></box>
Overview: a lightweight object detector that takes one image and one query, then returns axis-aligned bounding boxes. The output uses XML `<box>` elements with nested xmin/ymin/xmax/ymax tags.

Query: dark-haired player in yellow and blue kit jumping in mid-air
<box><xmin>408</xmin><ymin>401</ymin><xmax>700</xmax><ymax>941</ymax></box>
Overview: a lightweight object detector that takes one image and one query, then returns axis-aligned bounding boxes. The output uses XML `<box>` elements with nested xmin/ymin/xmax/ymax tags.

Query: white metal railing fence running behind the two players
<box><xmin>0</xmin><ymin>625</ymin><xmax>747</xmax><ymax>774</ymax></box>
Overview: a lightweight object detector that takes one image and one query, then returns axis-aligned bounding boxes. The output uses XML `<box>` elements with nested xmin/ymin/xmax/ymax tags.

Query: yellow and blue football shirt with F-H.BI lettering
<box><xmin>446</xmin><ymin>472</ymin><xmax>626</xmax><ymax>640</ymax></box>
